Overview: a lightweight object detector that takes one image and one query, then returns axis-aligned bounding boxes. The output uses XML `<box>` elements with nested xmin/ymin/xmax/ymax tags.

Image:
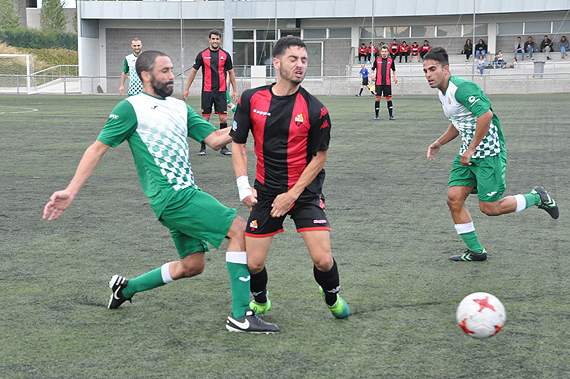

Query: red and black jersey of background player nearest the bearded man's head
<box><xmin>192</xmin><ymin>47</ymin><xmax>233</xmax><ymax>92</ymax></box>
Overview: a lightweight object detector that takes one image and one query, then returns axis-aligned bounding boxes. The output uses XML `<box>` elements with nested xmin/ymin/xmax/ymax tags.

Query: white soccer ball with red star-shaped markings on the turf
<box><xmin>456</xmin><ymin>292</ymin><xmax>507</xmax><ymax>339</ymax></box>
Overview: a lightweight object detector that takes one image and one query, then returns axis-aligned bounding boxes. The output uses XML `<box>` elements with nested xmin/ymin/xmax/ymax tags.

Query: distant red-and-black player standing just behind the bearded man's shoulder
<box><xmin>182</xmin><ymin>29</ymin><xmax>238</xmax><ymax>155</ymax></box>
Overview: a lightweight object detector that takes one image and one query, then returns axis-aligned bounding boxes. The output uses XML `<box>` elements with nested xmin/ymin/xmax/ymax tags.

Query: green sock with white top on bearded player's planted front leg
<box><xmin>226</xmin><ymin>251</ymin><xmax>251</xmax><ymax>318</ymax></box>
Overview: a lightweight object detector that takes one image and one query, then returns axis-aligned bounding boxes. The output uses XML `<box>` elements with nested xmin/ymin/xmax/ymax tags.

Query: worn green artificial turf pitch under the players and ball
<box><xmin>0</xmin><ymin>93</ymin><xmax>570</xmax><ymax>378</ymax></box>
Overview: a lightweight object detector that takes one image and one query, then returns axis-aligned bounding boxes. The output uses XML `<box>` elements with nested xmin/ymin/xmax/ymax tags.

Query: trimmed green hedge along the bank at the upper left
<box><xmin>0</xmin><ymin>28</ymin><xmax>77</xmax><ymax>51</ymax></box>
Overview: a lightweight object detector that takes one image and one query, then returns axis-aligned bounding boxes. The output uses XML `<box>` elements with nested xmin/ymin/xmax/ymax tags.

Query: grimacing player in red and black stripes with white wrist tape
<box><xmin>230</xmin><ymin>37</ymin><xmax>350</xmax><ymax>326</ymax></box>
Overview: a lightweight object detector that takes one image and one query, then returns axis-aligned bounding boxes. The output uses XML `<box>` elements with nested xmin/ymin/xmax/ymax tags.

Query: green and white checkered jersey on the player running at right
<box><xmin>439</xmin><ymin>76</ymin><xmax>505</xmax><ymax>158</ymax></box>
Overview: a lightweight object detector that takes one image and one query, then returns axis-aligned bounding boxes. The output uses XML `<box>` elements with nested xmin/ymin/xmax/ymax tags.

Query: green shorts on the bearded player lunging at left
<box><xmin>159</xmin><ymin>188</ymin><xmax>237</xmax><ymax>259</ymax></box>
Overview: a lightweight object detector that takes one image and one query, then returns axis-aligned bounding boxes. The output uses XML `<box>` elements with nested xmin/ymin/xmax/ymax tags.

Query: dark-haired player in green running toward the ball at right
<box><xmin>423</xmin><ymin>47</ymin><xmax>558</xmax><ymax>261</ymax></box>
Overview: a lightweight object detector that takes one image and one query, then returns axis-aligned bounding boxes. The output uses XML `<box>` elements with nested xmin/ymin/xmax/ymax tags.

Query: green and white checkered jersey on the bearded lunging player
<box><xmin>97</xmin><ymin>92</ymin><xmax>216</xmax><ymax>218</ymax></box>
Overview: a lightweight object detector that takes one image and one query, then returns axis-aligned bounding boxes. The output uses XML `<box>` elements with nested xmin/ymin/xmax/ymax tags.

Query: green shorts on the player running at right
<box><xmin>449</xmin><ymin>152</ymin><xmax>507</xmax><ymax>202</ymax></box>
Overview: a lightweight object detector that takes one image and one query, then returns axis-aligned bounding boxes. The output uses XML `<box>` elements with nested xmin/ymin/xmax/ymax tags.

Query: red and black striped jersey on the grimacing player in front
<box><xmin>230</xmin><ymin>85</ymin><xmax>331</xmax><ymax>194</ymax></box>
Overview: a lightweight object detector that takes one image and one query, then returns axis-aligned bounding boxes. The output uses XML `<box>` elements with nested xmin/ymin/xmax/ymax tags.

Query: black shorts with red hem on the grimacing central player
<box><xmin>245</xmin><ymin>187</ymin><xmax>331</xmax><ymax>238</ymax></box>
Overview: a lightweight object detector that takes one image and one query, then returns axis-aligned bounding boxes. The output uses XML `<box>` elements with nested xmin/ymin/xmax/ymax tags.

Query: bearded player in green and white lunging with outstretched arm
<box><xmin>43</xmin><ymin>51</ymin><xmax>279</xmax><ymax>333</ymax></box>
